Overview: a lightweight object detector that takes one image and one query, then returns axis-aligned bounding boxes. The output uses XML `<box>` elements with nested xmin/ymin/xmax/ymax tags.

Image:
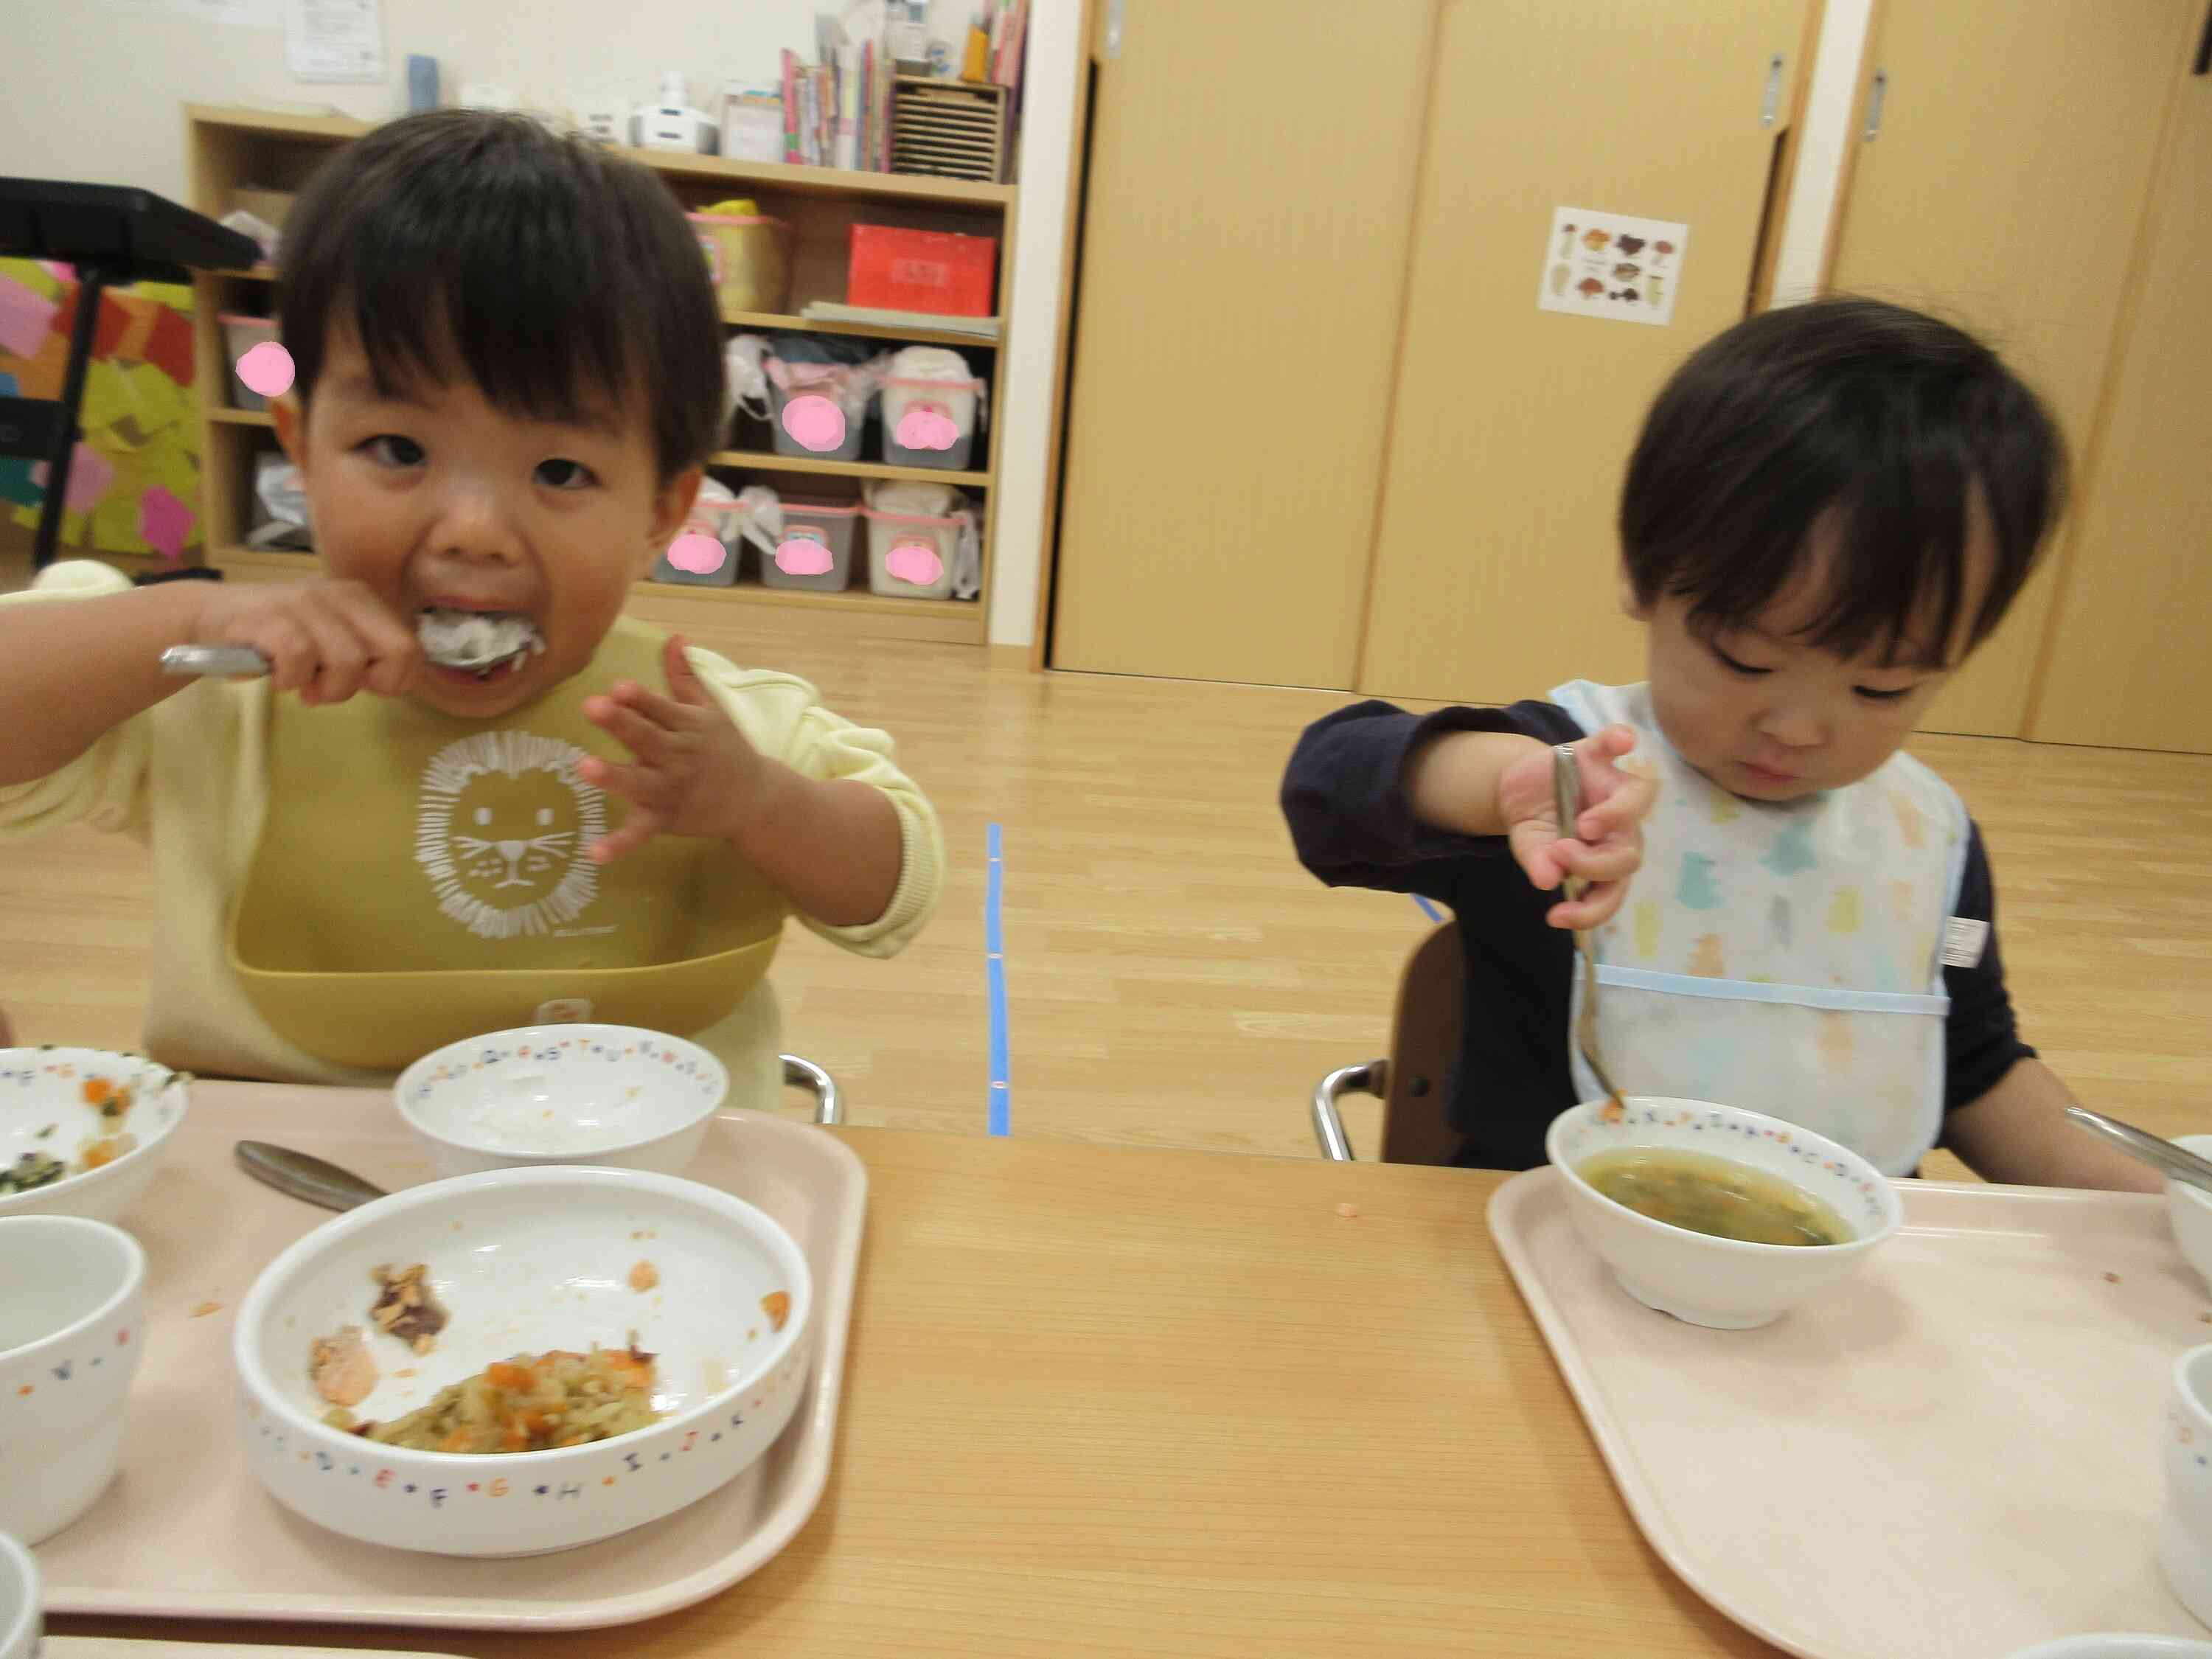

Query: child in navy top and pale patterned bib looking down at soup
<box><xmin>1283</xmin><ymin>301</ymin><xmax>2159</xmax><ymax>1190</ymax></box>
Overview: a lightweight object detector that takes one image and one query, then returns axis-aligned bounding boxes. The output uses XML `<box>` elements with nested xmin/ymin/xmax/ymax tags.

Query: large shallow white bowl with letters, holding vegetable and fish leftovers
<box><xmin>232</xmin><ymin>1168</ymin><xmax>814</xmax><ymax>1555</ymax></box>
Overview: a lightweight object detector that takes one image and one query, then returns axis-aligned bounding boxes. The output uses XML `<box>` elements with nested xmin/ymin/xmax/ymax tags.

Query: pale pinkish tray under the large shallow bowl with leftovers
<box><xmin>35</xmin><ymin>1082</ymin><xmax>867</xmax><ymax>1628</ymax></box>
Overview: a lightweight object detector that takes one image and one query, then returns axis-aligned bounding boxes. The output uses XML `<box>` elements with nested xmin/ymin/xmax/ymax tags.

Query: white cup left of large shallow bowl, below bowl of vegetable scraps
<box><xmin>0</xmin><ymin>1214</ymin><xmax>146</xmax><ymax>1544</ymax></box>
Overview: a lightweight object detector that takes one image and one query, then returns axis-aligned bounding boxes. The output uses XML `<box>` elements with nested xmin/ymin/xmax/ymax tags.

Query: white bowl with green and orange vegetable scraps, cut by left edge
<box><xmin>0</xmin><ymin>1048</ymin><xmax>190</xmax><ymax>1221</ymax></box>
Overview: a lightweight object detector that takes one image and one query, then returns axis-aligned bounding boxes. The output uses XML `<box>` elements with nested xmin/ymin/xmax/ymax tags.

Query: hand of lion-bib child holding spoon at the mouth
<box><xmin>184</xmin><ymin>582</ymin><xmax>422</xmax><ymax>703</ymax></box>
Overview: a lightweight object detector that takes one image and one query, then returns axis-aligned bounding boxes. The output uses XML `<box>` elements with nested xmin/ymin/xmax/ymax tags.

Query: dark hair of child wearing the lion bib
<box><xmin>281</xmin><ymin>111</ymin><xmax>723</xmax><ymax>482</ymax></box>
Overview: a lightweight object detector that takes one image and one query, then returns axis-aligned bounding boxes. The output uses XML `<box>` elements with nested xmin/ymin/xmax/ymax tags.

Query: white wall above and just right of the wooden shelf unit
<box><xmin>0</xmin><ymin>0</ymin><xmax>1082</xmax><ymax>644</ymax></box>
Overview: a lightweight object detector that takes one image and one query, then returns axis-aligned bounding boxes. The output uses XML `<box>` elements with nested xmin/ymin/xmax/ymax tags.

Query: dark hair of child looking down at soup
<box><xmin>1619</xmin><ymin>299</ymin><xmax>2066</xmax><ymax>655</ymax></box>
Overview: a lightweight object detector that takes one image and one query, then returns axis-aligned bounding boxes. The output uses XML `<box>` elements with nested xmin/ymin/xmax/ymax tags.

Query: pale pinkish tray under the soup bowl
<box><xmin>1489</xmin><ymin>1168</ymin><xmax>2212</xmax><ymax>1659</ymax></box>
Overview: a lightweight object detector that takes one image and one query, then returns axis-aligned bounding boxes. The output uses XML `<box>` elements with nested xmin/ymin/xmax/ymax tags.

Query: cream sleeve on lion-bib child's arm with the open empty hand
<box><xmin>688</xmin><ymin>648</ymin><xmax>945</xmax><ymax>956</ymax></box>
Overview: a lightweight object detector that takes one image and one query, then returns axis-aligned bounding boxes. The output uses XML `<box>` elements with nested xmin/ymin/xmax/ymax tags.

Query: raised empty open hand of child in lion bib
<box><xmin>577</xmin><ymin>639</ymin><xmax>772</xmax><ymax>865</ymax></box>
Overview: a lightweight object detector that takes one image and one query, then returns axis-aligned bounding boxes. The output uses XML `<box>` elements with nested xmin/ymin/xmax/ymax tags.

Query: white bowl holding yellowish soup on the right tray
<box><xmin>1544</xmin><ymin>1095</ymin><xmax>1905</xmax><ymax>1329</ymax></box>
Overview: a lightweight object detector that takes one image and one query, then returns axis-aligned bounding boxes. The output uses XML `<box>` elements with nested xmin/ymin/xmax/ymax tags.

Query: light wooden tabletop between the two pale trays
<box><xmin>55</xmin><ymin>1130</ymin><xmax>1774</xmax><ymax>1659</ymax></box>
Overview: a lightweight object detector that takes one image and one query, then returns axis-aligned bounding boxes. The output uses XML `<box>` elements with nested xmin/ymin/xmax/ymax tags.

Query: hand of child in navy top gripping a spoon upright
<box><xmin>1498</xmin><ymin>726</ymin><xmax>1659</xmax><ymax>931</ymax></box>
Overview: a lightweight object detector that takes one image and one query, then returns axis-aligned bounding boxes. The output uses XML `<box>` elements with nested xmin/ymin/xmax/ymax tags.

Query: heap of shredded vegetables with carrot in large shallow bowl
<box><xmin>327</xmin><ymin>1340</ymin><xmax>661</xmax><ymax>1453</ymax></box>
